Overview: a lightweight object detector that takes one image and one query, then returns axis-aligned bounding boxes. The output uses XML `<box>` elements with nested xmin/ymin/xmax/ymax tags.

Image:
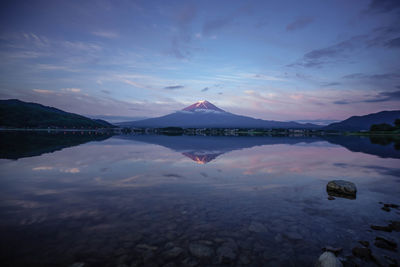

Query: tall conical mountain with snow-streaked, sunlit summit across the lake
<box><xmin>117</xmin><ymin>100</ymin><xmax>320</xmax><ymax>129</ymax></box>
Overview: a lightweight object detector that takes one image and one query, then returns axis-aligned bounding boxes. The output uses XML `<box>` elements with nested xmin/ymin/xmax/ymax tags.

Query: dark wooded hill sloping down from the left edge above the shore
<box><xmin>0</xmin><ymin>99</ymin><xmax>114</xmax><ymax>128</ymax></box>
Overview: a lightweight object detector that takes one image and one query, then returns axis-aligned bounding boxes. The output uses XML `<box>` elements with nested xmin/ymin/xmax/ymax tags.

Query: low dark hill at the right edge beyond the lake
<box><xmin>322</xmin><ymin>110</ymin><xmax>400</xmax><ymax>131</ymax></box>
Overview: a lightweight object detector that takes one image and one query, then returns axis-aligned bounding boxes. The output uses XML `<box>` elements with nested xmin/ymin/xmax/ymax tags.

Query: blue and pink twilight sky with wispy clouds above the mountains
<box><xmin>0</xmin><ymin>0</ymin><xmax>400</xmax><ymax>121</ymax></box>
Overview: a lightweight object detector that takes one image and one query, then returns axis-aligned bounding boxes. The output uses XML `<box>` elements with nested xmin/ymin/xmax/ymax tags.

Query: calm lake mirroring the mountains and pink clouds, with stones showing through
<box><xmin>0</xmin><ymin>132</ymin><xmax>400</xmax><ymax>267</ymax></box>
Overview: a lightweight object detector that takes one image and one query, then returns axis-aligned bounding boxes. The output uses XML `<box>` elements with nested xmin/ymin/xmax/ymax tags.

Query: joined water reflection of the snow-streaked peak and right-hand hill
<box><xmin>117</xmin><ymin>135</ymin><xmax>400</xmax><ymax>164</ymax></box>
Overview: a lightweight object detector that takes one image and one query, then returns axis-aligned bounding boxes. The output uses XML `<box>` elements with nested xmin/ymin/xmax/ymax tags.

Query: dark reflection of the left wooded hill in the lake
<box><xmin>0</xmin><ymin>131</ymin><xmax>111</xmax><ymax>159</ymax></box>
